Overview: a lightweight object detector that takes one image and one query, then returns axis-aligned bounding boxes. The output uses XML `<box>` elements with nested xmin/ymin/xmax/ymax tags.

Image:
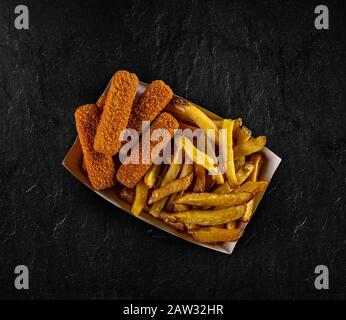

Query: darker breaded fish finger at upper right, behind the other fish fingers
<box><xmin>128</xmin><ymin>80</ymin><xmax>173</xmax><ymax>132</ymax></box>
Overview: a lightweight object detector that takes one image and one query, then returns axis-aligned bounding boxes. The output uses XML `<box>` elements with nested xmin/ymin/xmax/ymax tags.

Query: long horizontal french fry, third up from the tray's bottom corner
<box><xmin>174</xmin><ymin>192</ymin><xmax>253</xmax><ymax>207</ymax></box>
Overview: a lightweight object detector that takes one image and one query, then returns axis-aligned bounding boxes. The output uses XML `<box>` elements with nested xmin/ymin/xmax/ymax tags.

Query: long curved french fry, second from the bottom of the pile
<box><xmin>161</xmin><ymin>205</ymin><xmax>246</xmax><ymax>226</ymax></box>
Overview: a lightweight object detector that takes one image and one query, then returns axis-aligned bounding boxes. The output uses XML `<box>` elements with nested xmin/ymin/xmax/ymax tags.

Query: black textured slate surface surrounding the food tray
<box><xmin>0</xmin><ymin>0</ymin><xmax>346</xmax><ymax>299</ymax></box>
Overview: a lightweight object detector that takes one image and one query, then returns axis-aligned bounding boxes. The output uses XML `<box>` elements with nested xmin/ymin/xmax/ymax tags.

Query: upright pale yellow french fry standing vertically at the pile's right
<box><xmin>222</xmin><ymin>119</ymin><xmax>238</xmax><ymax>187</ymax></box>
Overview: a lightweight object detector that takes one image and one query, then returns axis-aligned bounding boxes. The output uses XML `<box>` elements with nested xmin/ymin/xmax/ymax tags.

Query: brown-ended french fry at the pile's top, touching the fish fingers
<box><xmin>166</xmin><ymin>98</ymin><xmax>219</xmax><ymax>144</ymax></box>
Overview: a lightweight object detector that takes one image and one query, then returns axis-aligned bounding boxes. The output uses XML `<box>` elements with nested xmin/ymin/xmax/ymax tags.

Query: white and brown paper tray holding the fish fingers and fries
<box><xmin>62</xmin><ymin>82</ymin><xmax>281</xmax><ymax>254</ymax></box>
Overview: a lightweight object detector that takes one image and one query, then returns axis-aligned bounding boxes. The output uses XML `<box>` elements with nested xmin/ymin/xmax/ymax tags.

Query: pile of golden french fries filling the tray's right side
<box><xmin>120</xmin><ymin>98</ymin><xmax>267</xmax><ymax>243</ymax></box>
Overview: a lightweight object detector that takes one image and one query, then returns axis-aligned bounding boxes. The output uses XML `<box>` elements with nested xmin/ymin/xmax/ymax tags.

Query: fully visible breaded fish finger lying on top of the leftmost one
<box><xmin>94</xmin><ymin>71</ymin><xmax>139</xmax><ymax>156</ymax></box>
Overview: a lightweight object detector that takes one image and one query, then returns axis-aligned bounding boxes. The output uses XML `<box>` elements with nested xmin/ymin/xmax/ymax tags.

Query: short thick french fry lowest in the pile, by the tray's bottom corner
<box><xmin>190</xmin><ymin>227</ymin><xmax>243</xmax><ymax>243</ymax></box>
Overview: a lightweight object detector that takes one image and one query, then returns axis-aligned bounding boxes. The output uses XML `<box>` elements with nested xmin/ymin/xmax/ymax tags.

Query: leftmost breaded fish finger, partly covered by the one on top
<box><xmin>75</xmin><ymin>104</ymin><xmax>116</xmax><ymax>190</ymax></box>
